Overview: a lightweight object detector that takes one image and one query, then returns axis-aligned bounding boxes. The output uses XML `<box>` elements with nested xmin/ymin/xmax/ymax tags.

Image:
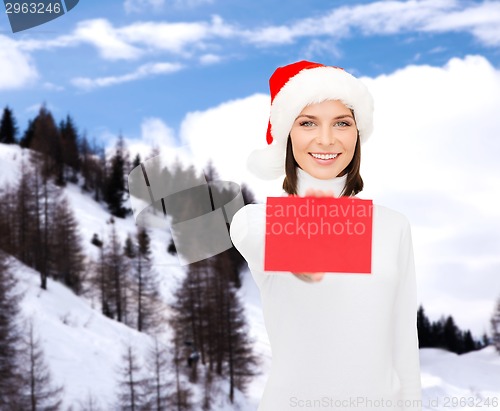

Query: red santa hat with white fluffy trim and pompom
<box><xmin>247</xmin><ymin>60</ymin><xmax>373</xmax><ymax>180</ymax></box>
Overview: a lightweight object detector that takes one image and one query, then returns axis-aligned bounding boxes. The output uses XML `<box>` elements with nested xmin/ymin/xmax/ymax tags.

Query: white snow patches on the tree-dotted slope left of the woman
<box><xmin>0</xmin><ymin>144</ymin><xmax>256</xmax><ymax>411</ymax></box>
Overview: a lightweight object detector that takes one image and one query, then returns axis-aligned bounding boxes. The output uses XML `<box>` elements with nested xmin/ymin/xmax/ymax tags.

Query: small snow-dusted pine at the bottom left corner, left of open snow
<box><xmin>21</xmin><ymin>320</ymin><xmax>63</xmax><ymax>411</ymax></box>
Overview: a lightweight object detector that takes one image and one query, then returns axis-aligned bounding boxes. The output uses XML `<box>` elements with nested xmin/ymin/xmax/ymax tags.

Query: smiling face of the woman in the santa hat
<box><xmin>290</xmin><ymin>100</ymin><xmax>358</xmax><ymax>180</ymax></box>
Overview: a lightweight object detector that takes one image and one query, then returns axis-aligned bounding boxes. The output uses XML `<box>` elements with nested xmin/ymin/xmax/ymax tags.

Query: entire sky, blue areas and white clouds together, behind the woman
<box><xmin>0</xmin><ymin>0</ymin><xmax>500</xmax><ymax>335</ymax></box>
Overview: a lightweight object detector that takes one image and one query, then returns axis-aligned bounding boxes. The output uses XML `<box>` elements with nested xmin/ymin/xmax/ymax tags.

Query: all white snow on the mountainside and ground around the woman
<box><xmin>0</xmin><ymin>144</ymin><xmax>500</xmax><ymax>411</ymax></box>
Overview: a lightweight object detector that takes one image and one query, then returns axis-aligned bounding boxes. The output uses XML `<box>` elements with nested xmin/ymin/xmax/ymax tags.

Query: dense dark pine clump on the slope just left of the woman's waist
<box><xmin>170</xmin><ymin>253</ymin><xmax>259</xmax><ymax>401</ymax></box>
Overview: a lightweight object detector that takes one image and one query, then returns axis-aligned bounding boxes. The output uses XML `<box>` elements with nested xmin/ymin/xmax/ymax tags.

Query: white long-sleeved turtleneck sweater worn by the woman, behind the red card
<box><xmin>231</xmin><ymin>172</ymin><xmax>422</xmax><ymax>411</ymax></box>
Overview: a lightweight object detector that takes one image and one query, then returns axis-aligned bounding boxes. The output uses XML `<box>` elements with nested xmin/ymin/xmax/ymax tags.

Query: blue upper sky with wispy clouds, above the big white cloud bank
<box><xmin>0</xmin><ymin>0</ymin><xmax>500</xmax><ymax>145</ymax></box>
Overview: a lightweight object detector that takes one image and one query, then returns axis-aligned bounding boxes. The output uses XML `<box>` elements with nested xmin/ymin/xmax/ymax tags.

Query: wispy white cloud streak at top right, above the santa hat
<box><xmin>241</xmin><ymin>0</ymin><xmax>500</xmax><ymax>46</ymax></box>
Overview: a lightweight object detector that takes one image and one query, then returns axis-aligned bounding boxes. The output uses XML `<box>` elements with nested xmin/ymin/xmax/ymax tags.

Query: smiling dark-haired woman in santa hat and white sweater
<box><xmin>231</xmin><ymin>61</ymin><xmax>422</xmax><ymax>411</ymax></box>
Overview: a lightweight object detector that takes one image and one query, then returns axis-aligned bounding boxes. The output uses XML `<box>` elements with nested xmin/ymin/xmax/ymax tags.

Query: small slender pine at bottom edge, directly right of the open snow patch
<box><xmin>119</xmin><ymin>346</ymin><xmax>145</xmax><ymax>411</ymax></box>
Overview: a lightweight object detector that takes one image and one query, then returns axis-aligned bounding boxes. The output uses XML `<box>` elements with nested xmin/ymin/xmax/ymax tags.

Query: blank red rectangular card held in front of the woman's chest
<box><xmin>264</xmin><ymin>197</ymin><xmax>373</xmax><ymax>274</ymax></box>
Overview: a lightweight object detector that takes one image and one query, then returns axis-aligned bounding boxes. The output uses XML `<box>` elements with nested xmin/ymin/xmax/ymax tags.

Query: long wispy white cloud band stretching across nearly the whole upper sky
<box><xmin>9</xmin><ymin>0</ymin><xmax>500</xmax><ymax>70</ymax></box>
